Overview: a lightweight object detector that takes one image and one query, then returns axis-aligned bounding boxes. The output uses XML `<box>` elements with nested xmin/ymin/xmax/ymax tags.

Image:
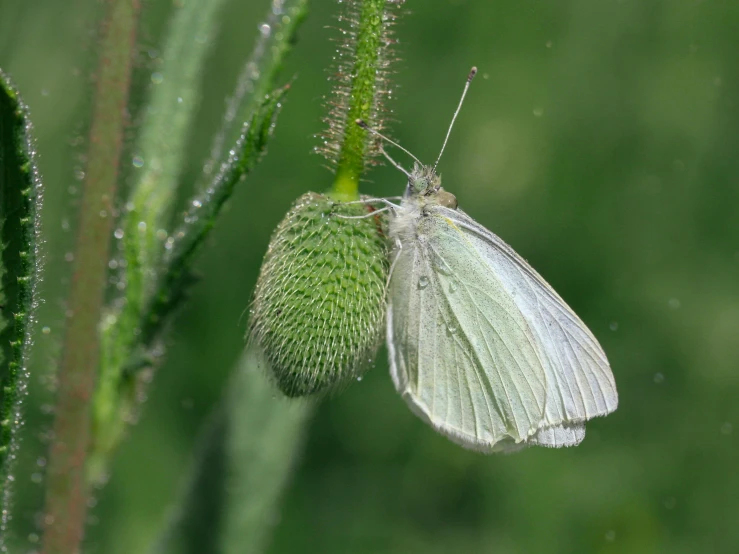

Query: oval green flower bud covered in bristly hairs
<box><xmin>249</xmin><ymin>192</ymin><xmax>388</xmax><ymax>397</ymax></box>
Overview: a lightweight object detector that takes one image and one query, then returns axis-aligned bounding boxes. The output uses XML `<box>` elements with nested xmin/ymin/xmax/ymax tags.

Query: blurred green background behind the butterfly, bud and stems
<box><xmin>0</xmin><ymin>0</ymin><xmax>739</xmax><ymax>554</ymax></box>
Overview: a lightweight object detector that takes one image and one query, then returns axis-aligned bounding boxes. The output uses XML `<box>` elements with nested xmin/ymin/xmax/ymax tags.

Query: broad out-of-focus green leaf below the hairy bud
<box><xmin>152</xmin><ymin>349</ymin><xmax>314</xmax><ymax>554</ymax></box>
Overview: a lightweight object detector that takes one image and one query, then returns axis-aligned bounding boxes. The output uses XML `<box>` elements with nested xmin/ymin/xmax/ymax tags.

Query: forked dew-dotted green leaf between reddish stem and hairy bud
<box><xmin>89</xmin><ymin>0</ymin><xmax>308</xmax><ymax>482</ymax></box>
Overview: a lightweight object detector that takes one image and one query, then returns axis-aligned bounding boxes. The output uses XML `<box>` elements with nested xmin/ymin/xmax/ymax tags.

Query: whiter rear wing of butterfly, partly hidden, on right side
<box><xmin>440</xmin><ymin>204</ymin><xmax>618</xmax><ymax>436</ymax></box>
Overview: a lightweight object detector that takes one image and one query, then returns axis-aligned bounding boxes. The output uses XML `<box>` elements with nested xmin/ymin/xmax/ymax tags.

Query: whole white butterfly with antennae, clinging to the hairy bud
<box><xmin>360</xmin><ymin>68</ymin><xmax>618</xmax><ymax>452</ymax></box>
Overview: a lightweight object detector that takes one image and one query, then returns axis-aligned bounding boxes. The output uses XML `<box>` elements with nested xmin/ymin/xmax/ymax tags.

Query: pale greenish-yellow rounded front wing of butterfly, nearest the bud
<box><xmin>387</xmin><ymin>210</ymin><xmax>547</xmax><ymax>452</ymax></box>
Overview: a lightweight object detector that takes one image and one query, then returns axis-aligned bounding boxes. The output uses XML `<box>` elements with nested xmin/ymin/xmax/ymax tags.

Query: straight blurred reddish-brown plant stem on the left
<box><xmin>42</xmin><ymin>0</ymin><xmax>139</xmax><ymax>554</ymax></box>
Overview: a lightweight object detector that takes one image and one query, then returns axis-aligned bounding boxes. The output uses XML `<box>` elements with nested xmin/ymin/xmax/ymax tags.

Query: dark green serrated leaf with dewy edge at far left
<box><xmin>0</xmin><ymin>70</ymin><xmax>42</xmax><ymax>548</ymax></box>
